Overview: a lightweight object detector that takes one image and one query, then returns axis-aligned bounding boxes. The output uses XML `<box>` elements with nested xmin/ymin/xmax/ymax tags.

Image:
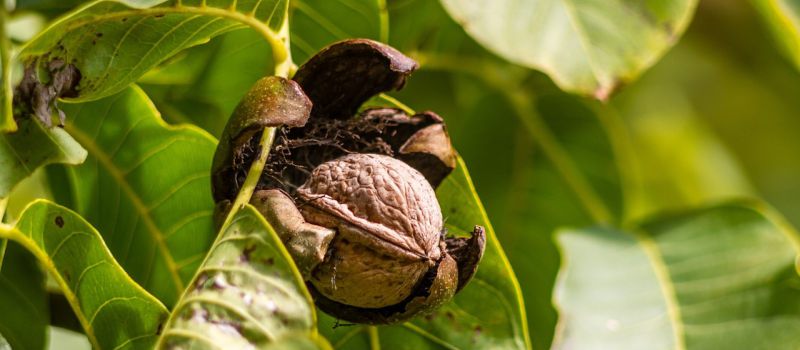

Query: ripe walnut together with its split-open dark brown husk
<box><xmin>212</xmin><ymin>39</ymin><xmax>485</xmax><ymax>324</ymax></box>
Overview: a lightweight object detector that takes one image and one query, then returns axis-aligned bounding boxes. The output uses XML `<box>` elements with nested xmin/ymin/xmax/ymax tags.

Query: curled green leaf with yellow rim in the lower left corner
<box><xmin>0</xmin><ymin>200</ymin><xmax>167</xmax><ymax>349</ymax></box>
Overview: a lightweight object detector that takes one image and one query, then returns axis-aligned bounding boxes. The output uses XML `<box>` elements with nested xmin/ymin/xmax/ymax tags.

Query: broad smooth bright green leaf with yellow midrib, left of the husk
<box><xmin>52</xmin><ymin>86</ymin><xmax>216</xmax><ymax>306</ymax></box>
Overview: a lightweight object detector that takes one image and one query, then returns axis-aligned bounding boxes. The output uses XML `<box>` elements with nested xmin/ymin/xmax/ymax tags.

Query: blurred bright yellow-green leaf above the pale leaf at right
<box><xmin>614</xmin><ymin>79</ymin><xmax>756</xmax><ymax>218</ymax></box>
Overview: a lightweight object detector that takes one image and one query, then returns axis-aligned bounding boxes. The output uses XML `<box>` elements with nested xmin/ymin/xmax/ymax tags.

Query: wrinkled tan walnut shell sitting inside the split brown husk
<box><xmin>297</xmin><ymin>154</ymin><xmax>443</xmax><ymax>308</ymax></box>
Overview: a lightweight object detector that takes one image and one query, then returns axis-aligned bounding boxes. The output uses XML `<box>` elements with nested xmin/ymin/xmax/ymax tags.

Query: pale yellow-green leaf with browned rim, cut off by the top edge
<box><xmin>441</xmin><ymin>0</ymin><xmax>697</xmax><ymax>100</ymax></box>
